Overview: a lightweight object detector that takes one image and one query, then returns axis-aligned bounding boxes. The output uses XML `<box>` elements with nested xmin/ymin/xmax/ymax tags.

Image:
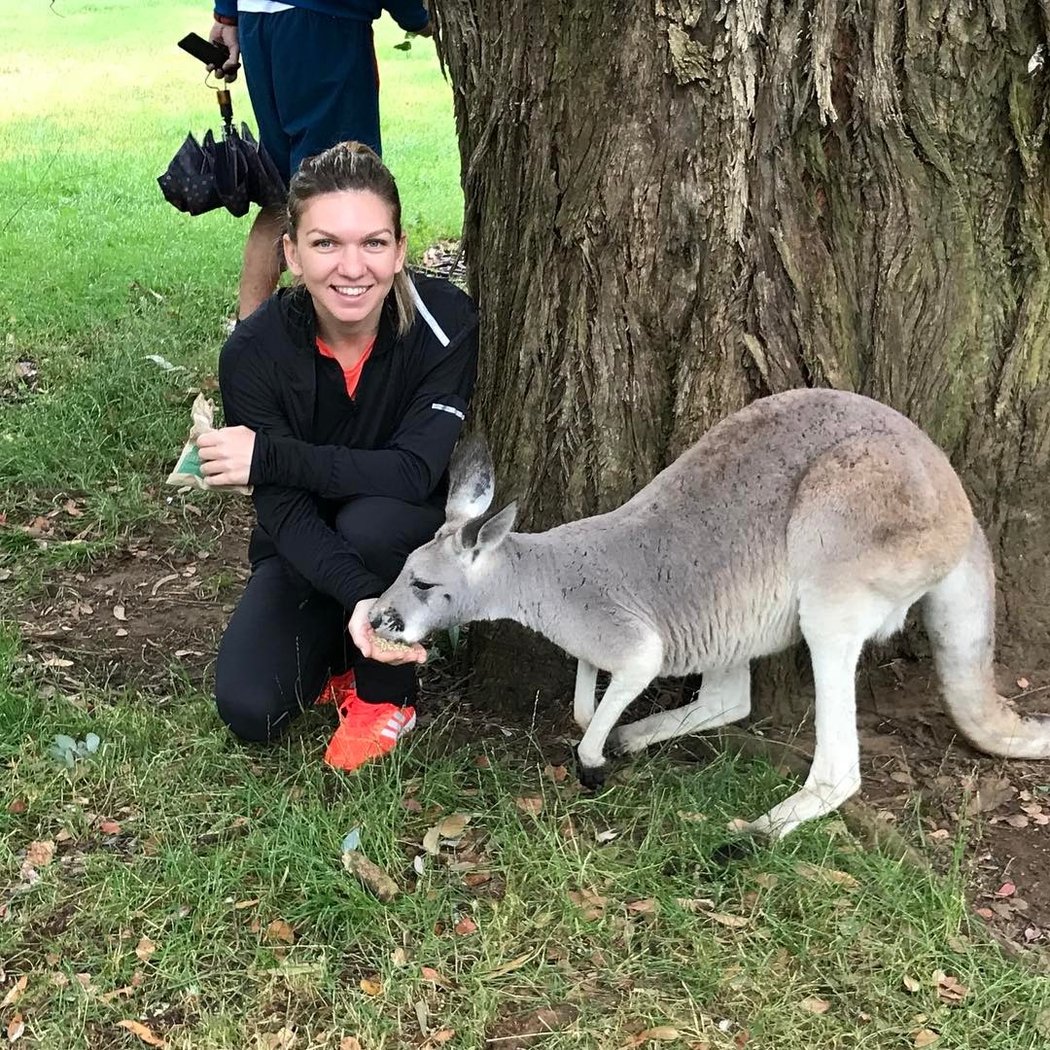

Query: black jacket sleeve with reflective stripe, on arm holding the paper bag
<box><xmin>251</xmin><ymin>318</ymin><xmax>478</xmax><ymax>503</ymax></box>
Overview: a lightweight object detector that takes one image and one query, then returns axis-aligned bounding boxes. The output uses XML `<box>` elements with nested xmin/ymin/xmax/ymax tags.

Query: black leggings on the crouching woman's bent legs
<box><xmin>215</xmin><ymin>496</ymin><xmax>444</xmax><ymax>740</ymax></box>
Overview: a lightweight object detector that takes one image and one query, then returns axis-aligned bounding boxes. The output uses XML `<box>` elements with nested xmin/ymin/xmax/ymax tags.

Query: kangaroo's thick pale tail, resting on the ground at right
<box><xmin>923</xmin><ymin>522</ymin><xmax>1050</xmax><ymax>758</ymax></box>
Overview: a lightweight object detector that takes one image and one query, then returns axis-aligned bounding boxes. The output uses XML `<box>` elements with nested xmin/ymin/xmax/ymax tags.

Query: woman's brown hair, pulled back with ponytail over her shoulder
<box><xmin>287</xmin><ymin>142</ymin><xmax>416</xmax><ymax>335</ymax></box>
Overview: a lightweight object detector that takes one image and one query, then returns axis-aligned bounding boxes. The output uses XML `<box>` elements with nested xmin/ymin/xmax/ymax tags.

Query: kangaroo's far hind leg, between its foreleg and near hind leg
<box><xmin>608</xmin><ymin>662</ymin><xmax>751</xmax><ymax>755</ymax></box>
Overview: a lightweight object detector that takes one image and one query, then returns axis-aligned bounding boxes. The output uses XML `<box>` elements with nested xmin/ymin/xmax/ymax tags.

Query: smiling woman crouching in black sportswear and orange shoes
<box><xmin>198</xmin><ymin>143</ymin><xmax>478</xmax><ymax>770</ymax></box>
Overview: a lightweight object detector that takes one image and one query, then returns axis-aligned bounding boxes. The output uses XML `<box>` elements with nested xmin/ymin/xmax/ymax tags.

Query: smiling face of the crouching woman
<box><xmin>285</xmin><ymin>190</ymin><xmax>405</xmax><ymax>336</ymax></box>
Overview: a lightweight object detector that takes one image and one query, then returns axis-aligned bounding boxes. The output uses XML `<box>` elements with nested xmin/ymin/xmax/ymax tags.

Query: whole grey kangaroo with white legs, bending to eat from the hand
<box><xmin>371</xmin><ymin>390</ymin><xmax>1050</xmax><ymax>838</ymax></box>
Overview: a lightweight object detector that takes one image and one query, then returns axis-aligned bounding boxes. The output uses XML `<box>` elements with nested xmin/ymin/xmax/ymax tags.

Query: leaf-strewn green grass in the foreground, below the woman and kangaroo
<box><xmin>0</xmin><ymin>637</ymin><xmax>1048</xmax><ymax>1050</ymax></box>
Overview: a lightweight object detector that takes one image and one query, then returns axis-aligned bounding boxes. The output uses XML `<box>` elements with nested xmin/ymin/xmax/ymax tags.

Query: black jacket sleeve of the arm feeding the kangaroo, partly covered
<box><xmin>218</xmin><ymin>335</ymin><xmax>384</xmax><ymax>609</ymax></box>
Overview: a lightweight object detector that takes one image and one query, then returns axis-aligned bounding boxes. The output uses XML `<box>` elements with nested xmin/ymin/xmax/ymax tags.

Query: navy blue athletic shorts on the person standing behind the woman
<box><xmin>237</xmin><ymin>7</ymin><xmax>382</xmax><ymax>182</ymax></box>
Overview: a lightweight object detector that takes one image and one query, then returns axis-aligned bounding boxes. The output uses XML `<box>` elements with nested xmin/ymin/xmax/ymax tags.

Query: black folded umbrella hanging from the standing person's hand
<box><xmin>156</xmin><ymin>88</ymin><xmax>288</xmax><ymax>216</ymax></box>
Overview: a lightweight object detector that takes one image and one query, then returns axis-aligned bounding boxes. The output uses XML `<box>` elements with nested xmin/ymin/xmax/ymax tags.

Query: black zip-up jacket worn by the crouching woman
<box><xmin>218</xmin><ymin>275</ymin><xmax>478</xmax><ymax>609</ymax></box>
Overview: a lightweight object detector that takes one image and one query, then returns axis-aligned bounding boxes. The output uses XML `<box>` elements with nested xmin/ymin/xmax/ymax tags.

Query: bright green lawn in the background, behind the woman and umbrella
<box><xmin>0</xmin><ymin>0</ymin><xmax>462</xmax><ymax>533</ymax></box>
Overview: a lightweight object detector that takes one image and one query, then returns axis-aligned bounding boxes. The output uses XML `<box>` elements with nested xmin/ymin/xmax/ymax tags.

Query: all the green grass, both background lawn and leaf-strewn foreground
<box><xmin>0</xmin><ymin>0</ymin><xmax>1050</xmax><ymax>1050</ymax></box>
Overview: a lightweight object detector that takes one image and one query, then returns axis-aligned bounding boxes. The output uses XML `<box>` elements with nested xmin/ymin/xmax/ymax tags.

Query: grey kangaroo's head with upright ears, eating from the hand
<box><xmin>370</xmin><ymin>437</ymin><xmax>518</xmax><ymax>643</ymax></box>
